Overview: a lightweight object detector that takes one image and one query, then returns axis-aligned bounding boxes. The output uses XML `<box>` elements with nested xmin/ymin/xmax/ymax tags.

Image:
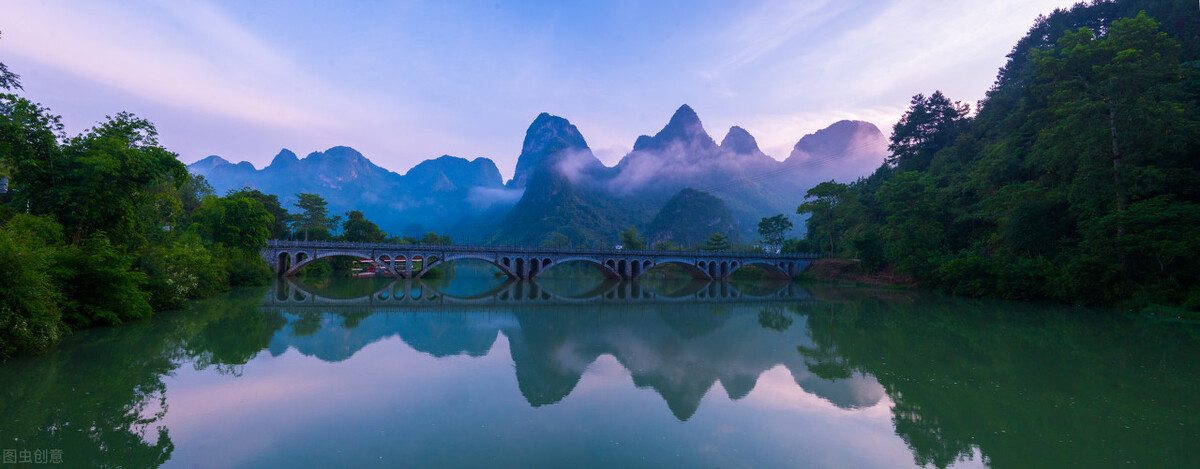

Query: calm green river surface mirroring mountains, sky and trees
<box><xmin>0</xmin><ymin>276</ymin><xmax>1200</xmax><ymax>468</ymax></box>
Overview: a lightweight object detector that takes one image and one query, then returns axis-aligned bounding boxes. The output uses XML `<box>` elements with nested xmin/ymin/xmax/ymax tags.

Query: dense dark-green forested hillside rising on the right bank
<box><xmin>800</xmin><ymin>0</ymin><xmax>1200</xmax><ymax>313</ymax></box>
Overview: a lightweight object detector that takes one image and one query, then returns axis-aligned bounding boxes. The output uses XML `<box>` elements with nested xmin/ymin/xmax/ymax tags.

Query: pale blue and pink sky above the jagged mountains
<box><xmin>0</xmin><ymin>0</ymin><xmax>1074</xmax><ymax>179</ymax></box>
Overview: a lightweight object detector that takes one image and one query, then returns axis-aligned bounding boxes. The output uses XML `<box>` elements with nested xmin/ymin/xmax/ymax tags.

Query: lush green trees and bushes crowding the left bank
<box><xmin>0</xmin><ymin>52</ymin><xmax>290</xmax><ymax>357</ymax></box>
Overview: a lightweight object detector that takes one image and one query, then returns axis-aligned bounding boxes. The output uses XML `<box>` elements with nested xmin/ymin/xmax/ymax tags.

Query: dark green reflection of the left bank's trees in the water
<box><xmin>0</xmin><ymin>284</ymin><xmax>290</xmax><ymax>468</ymax></box>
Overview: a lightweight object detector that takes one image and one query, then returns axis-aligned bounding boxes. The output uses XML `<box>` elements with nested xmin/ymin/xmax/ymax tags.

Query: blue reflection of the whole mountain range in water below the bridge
<box><xmin>260</xmin><ymin>282</ymin><xmax>883</xmax><ymax>420</ymax></box>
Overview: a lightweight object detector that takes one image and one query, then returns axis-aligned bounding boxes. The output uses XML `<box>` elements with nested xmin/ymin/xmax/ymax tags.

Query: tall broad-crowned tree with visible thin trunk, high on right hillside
<box><xmin>1034</xmin><ymin>12</ymin><xmax>1196</xmax><ymax>220</ymax></box>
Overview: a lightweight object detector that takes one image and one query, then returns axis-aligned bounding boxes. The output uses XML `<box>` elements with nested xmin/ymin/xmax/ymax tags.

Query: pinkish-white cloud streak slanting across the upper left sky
<box><xmin>0</xmin><ymin>0</ymin><xmax>338</xmax><ymax>128</ymax></box>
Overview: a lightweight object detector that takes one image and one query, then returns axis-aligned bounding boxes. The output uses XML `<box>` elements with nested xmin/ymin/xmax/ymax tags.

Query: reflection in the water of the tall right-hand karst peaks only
<box><xmin>505</xmin><ymin>305</ymin><xmax>883</xmax><ymax>420</ymax></box>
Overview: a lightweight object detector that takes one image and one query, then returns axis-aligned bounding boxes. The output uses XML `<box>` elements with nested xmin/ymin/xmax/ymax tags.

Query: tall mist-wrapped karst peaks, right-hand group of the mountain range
<box><xmin>494</xmin><ymin>104</ymin><xmax>887</xmax><ymax>246</ymax></box>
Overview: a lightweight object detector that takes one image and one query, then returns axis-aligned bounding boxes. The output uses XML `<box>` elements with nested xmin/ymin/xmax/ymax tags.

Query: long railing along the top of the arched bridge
<box><xmin>266</xmin><ymin>240</ymin><xmax>821</xmax><ymax>260</ymax></box>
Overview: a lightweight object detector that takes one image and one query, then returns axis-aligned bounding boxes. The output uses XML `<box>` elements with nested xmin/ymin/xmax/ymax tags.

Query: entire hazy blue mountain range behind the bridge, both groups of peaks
<box><xmin>188</xmin><ymin>104</ymin><xmax>887</xmax><ymax>246</ymax></box>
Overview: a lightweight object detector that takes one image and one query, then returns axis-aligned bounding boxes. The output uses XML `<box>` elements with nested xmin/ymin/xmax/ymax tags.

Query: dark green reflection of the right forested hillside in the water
<box><xmin>800</xmin><ymin>290</ymin><xmax>1200</xmax><ymax>468</ymax></box>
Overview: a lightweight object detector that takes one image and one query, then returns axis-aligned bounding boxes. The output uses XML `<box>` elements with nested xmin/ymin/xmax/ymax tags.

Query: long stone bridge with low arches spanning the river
<box><xmin>263</xmin><ymin>240</ymin><xmax>820</xmax><ymax>279</ymax></box>
